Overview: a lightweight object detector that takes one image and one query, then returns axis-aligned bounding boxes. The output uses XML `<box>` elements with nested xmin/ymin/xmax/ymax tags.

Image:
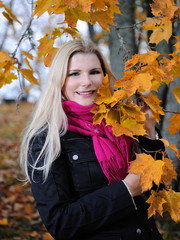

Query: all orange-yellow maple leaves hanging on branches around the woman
<box><xmin>0</xmin><ymin>0</ymin><xmax>180</xmax><ymax>225</ymax></box>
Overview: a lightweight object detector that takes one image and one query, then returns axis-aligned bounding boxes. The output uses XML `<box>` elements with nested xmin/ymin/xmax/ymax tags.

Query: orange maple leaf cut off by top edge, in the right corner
<box><xmin>150</xmin><ymin>0</ymin><xmax>179</xmax><ymax>19</ymax></box>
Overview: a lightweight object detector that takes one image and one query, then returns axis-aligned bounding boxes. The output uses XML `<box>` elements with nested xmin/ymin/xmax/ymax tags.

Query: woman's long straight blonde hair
<box><xmin>20</xmin><ymin>39</ymin><xmax>115</xmax><ymax>181</ymax></box>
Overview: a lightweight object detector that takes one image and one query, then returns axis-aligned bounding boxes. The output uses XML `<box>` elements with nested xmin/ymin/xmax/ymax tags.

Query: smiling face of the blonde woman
<box><xmin>62</xmin><ymin>53</ymin><xmax>104</xmax><ymax>106</ymax></box>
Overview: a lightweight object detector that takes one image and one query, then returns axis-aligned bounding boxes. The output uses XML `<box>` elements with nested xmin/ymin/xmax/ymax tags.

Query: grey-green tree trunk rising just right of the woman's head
<box><xmin>109</xmin><ymin>0</ymin><xmax>136</xmax><ymax>78</ymax></box>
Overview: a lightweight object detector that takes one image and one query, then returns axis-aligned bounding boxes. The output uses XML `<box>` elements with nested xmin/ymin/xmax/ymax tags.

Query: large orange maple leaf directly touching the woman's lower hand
<box><xmin>129</xmin><ymin>153</ymin><xmax>164</xmax><ymax>191</ymax></box>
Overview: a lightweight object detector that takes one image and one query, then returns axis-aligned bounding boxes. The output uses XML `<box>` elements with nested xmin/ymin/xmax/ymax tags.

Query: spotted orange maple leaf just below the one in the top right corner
<box><xmin>142</xmin><ymin>17</ymin><xmax>172</xmax><ymax>44</ymax></box>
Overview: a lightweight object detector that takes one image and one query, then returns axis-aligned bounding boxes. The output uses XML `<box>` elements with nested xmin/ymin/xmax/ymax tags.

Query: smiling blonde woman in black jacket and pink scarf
<box><xmin>20</xmin><ymin>40</ymin><xmax>165</xmax><ymax>240</ymax></box>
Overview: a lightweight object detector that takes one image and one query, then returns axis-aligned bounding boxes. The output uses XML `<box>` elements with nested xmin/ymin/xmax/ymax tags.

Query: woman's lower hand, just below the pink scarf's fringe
<box><xmin>123</xmin><ymin>173</ymin><xmax>143</xmax><ymax>197</ymax></box>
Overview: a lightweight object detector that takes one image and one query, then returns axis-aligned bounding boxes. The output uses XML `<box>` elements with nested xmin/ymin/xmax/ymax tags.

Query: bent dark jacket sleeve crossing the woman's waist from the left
<box><xmin>29</xmin><ymin>134</ymin><xmax>135</xmax><ymax>240</ymax></box>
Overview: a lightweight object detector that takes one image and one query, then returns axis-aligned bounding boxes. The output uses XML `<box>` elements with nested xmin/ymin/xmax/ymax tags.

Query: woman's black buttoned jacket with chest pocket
<box><xmin>29</xmin><ymin>132</ymin><xmax>163</xmax><ymax>240</ymax></box>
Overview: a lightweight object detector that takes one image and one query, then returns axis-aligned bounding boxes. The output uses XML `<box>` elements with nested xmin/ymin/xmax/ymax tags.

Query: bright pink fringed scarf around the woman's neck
<box><xmin>63</xmin><ymin>101</ymin><xmax>134</xmax><ymax>184</ymax></box>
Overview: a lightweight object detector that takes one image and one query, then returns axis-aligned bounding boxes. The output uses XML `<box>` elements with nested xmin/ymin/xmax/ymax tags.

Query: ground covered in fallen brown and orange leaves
<box><xmin>0</xmin><ymin>102</ymin><xmax>180</xmax><ymax>240</ymax></box>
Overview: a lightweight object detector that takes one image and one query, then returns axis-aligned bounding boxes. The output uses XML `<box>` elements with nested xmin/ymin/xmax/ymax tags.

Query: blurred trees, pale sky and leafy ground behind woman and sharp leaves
<box><xmin>0</xmin><ymin>0</ymin><xmax>180</xmax><ymax>240</ymax></box>
